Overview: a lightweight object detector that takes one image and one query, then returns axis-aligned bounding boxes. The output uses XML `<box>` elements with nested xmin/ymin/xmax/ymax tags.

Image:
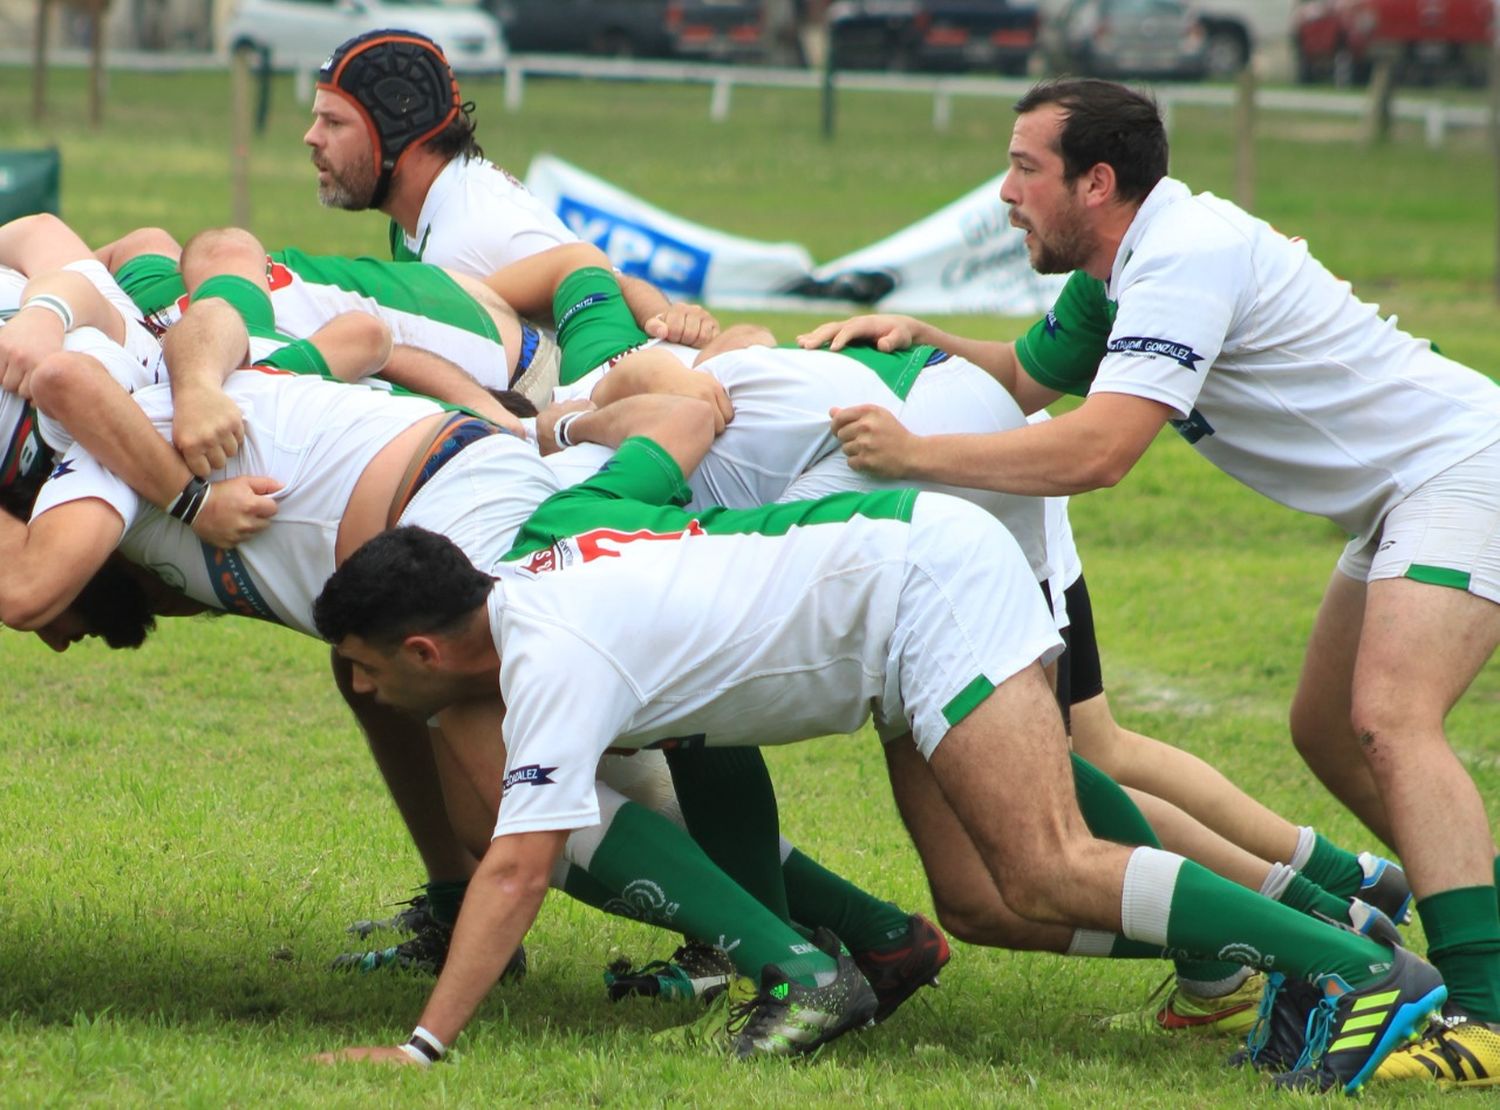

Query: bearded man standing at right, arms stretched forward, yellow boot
<box><xmin>804</xmin><ymin>81</ymin><xmax>1500</xmax><ymax>1085</ymax></box>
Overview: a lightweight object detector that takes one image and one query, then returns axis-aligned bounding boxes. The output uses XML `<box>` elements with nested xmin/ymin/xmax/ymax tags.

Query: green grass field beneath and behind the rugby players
<box><xmin>0</xmin><ymin>69</ymin><xmax>1500</xmax><ymax>1107</ymax></box>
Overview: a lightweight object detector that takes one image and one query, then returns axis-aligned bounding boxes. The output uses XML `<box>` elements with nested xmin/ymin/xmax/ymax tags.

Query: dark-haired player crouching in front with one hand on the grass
<box><xmin>315</xmin><ymin>438</ymin><xmax>1445</xmax><ymax>1091</ymax></box>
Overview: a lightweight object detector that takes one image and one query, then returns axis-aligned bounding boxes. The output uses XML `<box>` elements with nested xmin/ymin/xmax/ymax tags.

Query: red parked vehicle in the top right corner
<box><xmin>1292</xmin><ymin>0</ymin><xmax>1494</xmax><ymax>86</ymax></box>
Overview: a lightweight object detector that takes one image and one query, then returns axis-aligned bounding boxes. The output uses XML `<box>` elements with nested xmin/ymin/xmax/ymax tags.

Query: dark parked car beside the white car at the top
<box><xmin>492</xmin><ymin>0</ymin><xmax>672</xmax><ymax>57</ymax></box>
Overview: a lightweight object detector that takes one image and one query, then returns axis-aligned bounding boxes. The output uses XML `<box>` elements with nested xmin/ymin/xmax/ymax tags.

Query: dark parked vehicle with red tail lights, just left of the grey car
<box><xmin>828</xmin><ymin>0</ymin><xmax>1040</xmax><ymax>75</ymax></box>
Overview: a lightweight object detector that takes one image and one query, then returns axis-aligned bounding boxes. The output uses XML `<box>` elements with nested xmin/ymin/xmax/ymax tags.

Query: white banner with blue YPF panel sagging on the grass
<box><xmin>527</xmin><ymin>155</ymin><xmax>1064</xmax><ymax>317</ymax></box>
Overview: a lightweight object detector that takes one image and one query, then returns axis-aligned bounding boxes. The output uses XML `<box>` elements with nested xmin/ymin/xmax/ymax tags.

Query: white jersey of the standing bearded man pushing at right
<box><xmin>1091</xmin><ymin>179</ymin><xmax>1500</xmax><ymax>539</ymax></box>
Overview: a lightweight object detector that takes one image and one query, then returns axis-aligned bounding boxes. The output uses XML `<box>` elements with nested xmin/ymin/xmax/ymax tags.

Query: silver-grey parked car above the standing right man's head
<box><xmin>1043</xmin><ymin>0</ymin><xmax>1208</xmax><ymax>81</ymax></box>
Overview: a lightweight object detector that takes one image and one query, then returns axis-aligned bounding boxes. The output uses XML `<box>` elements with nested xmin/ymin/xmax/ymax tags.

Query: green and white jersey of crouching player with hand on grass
<box><xmin>489</xmin><ymin>440</ymin><xmax>924</xmax><ymax>836</ymax></box>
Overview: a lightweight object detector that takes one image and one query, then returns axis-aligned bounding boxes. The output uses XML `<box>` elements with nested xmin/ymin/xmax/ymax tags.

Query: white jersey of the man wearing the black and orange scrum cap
<box><xmin>390</xmin><ymin>158</ymin><xmax>578</xmax><ymax>278</ymax></box>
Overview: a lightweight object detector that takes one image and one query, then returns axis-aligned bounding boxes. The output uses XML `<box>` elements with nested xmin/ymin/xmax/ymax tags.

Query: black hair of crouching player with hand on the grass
<box><xmin>312</xmin><ymin>525</ymin><xmax>495</xmax><ymax>648</ymax></box>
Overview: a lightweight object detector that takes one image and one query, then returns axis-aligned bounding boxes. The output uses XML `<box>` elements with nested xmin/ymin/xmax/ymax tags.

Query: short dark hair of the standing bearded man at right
<box><xmin>1016</xmin><ymin>78</ymin><xmax>1167</xmax><ymax>201</ymax></box>
